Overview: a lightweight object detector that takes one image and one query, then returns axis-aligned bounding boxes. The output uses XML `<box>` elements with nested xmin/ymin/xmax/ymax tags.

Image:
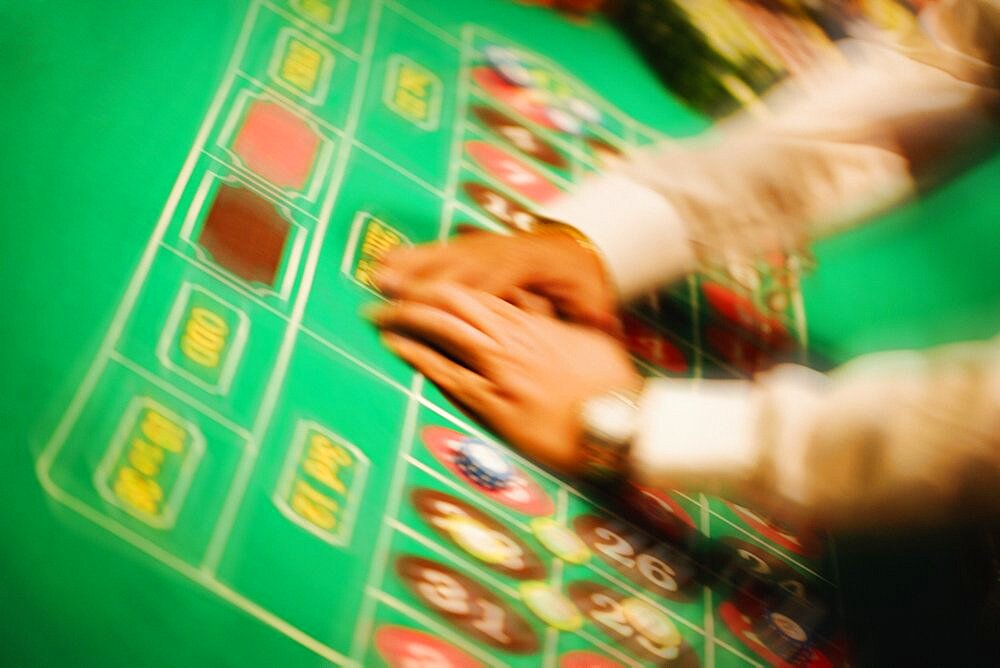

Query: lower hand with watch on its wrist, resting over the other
<box><xmin>372</xmin><ymin>283</ymin><xmax>641</xmax><ymax>473</ymax></box>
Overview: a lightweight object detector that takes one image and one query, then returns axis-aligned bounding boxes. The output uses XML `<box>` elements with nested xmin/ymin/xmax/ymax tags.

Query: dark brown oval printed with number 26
<box><xmin>573</xmin><ymin>515</ymin><xmax>701</xmax><ymax>601</ymax></box>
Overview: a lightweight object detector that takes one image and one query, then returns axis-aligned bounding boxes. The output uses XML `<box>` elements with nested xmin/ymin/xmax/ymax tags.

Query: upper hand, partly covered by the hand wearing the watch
<box><xmin>375</xmin><ymin>230</ymin><xmax>618</xmax><ymax>332</ymax></box>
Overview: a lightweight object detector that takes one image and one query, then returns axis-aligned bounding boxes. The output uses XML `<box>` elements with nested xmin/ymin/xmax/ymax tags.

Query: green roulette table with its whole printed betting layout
<box><xmin>0</xmin><ymin>0</ymin><xmax>1000</xmax><ymax>668</ymax></box>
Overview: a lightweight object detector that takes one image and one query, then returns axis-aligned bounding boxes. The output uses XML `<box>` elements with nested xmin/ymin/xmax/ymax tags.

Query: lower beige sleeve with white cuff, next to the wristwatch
<box><xmin>632</xmin><ymin>338</ymin><xmax>1000</xmax><ymax>527</ymax></box>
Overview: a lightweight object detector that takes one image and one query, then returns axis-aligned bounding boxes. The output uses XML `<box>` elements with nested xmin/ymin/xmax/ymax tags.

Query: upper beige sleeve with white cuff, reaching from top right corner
<box><xmin>547</xmin><ymin>0</ymin><xmax>1000</xmax><ymax>299</ymax></box>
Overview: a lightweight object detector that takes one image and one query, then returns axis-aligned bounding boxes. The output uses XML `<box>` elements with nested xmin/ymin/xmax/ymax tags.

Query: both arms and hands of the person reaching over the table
<box><xmin>377</xmin><ymin>0</ymin><xmax>1000</xmax><ymax>525</ymax></box>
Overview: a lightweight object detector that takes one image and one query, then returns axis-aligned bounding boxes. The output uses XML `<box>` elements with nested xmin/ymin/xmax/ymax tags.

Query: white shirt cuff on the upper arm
<box><xmin>545</xmin><ymin>174</ymin><xmax>695</xmax><ymax>300</ymax></box>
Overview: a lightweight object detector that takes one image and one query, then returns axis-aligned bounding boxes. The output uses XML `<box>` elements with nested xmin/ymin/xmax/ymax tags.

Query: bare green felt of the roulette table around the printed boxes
<box><xmin>0</xmin><ymin>0</ymin><xmax>1000</xmax><ymax>666</ymax></box>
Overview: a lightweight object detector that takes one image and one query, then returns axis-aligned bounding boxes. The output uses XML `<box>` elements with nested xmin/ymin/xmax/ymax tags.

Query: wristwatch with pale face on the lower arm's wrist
<box><xmin>580</xmin><ymin>390</ymin><xmax>641</xmax><ymax>487</ymax></box>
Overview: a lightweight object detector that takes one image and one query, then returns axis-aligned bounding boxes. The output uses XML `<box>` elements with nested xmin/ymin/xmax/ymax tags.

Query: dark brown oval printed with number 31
<box><xmin>396</xmin><ymin>555</ymin><xmax>540</xmax><ymax>654</ymax></box>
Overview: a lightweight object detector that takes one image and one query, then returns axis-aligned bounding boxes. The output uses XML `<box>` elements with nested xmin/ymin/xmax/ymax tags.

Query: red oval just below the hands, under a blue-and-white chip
<box><xmin>421</xmin><ymin>427</ymin><xmax>555</xmax><ymax>517</ymax></box>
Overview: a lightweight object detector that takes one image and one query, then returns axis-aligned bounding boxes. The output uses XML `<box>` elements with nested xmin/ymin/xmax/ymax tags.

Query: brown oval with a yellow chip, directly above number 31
<box><xmin>410</xmin><ymin>488</ymin><xmax>546</xmax><ymax>580</ymax></box>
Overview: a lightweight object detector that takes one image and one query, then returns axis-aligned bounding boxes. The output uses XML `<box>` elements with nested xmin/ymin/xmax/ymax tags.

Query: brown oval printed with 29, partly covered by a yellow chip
<box><xmin>566</xmin><ymin>580</ymin><xmax>701</xmax><ymax>668</ymax></box>
